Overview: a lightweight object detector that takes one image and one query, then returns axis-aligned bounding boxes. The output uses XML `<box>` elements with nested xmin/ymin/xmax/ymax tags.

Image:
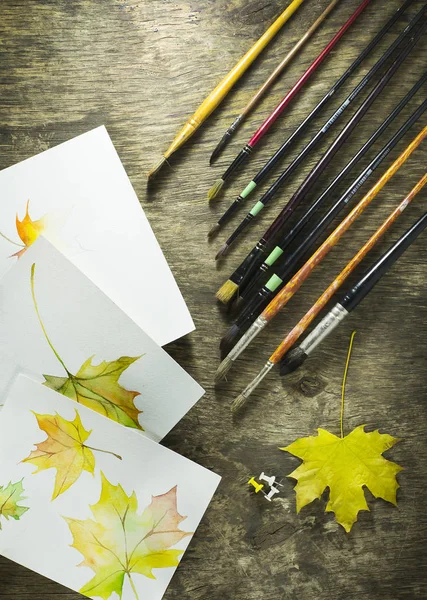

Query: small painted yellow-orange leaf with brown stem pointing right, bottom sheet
<box><xmin>22</xmin><ymin>410</ymin><xmax>120</xmax><ymax>500</ymax></box>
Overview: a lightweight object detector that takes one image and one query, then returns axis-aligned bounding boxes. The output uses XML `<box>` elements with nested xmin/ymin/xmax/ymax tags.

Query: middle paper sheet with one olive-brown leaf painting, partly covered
<box><xmin>0</xmin><ymin>236</ymin><xmax>203</xmax><ymax>441</ymax></box>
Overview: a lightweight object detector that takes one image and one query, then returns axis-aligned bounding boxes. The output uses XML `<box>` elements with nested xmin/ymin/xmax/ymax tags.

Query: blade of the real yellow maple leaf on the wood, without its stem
<box><xmin>281</xmin><ymin>425</ymin><xmax>402</xmax><ymax>533</ymax></box>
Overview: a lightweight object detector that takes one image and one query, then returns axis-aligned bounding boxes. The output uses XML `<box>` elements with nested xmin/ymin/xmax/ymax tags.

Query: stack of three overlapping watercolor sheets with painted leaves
<box><xmin>0</xmin><ymin>128</ymin><xmax>220</xmax><ymax>600</ymax></box>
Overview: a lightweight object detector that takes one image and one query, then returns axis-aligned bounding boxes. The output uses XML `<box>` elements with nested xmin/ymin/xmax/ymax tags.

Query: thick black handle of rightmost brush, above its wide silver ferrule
<box><xmin>340</xmin><ymin>212</ymin><xmax>427</xmax><ymax>312</ymax></box>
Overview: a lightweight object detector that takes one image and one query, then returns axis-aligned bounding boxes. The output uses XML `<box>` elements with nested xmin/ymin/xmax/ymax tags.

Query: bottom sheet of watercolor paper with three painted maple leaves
<box><xmin>0</xmin><ymin>376</ymin><xmax>220</xmax><ymax>600</ymax></box>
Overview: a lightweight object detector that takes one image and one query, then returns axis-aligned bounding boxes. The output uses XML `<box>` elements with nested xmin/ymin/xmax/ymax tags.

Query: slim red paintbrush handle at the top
<box><xmin>248</xmin><ymin>0</ymin><xmax>371</xmax><ymax>148</ymax></box>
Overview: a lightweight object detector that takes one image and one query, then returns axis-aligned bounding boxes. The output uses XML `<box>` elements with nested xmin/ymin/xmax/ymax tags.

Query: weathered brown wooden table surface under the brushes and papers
<box><xmin>0</xmin><ymin>0</ymin><xmax>427</xmax><ymax>600</ymax></box>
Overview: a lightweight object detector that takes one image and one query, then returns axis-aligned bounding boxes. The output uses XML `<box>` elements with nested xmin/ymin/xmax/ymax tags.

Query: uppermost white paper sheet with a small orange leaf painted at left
<box><xmin>0</xmin><ymin>127</ymin><xmax>194</xmax><ymax>346</ymax></box>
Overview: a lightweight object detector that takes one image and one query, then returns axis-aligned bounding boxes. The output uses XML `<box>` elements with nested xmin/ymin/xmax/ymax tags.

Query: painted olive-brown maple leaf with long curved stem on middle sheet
<box><xmin>31</xmin><ymin>263</ymin><xmax>144</xmax><ymax>431</ymax></box>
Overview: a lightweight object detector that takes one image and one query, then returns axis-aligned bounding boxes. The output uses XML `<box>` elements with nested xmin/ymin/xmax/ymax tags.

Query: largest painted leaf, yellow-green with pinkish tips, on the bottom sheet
<box><xmin>66</xmin><ymin>473</ymin><xmax>192</xmax><ymax>600</ymax></box>
